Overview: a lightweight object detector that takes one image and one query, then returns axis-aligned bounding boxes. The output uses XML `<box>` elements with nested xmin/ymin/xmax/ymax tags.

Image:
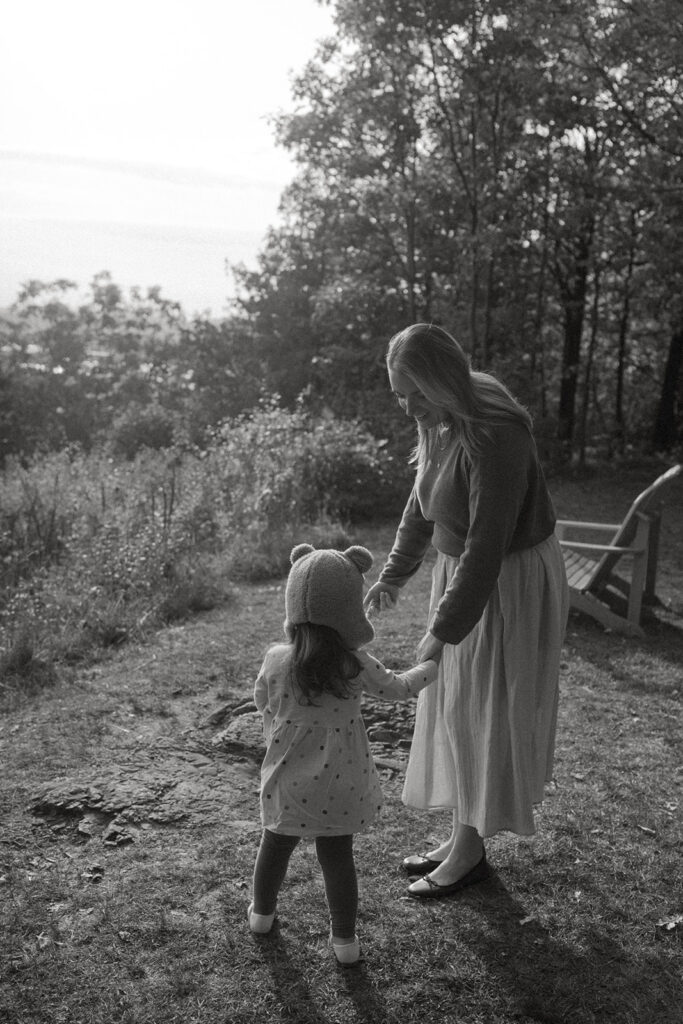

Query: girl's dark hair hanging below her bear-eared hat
<box><xmin>289</xmin><ymin>623</ymin><xmax>362</xmax><ymax>705</ymax></box>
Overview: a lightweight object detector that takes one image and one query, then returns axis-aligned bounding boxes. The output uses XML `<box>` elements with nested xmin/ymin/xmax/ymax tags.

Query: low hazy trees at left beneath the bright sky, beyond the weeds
<box><xmin>0</xmin><ymin>273</ymin><xmax>262</xmax><ymax>463</ymax></box>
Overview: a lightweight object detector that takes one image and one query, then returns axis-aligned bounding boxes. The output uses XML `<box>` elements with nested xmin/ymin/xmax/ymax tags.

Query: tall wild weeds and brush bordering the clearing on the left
<box><xmin>0</xmin><ymin>401</ymin><xmax>401</xmax><ymax>678</ymax></box>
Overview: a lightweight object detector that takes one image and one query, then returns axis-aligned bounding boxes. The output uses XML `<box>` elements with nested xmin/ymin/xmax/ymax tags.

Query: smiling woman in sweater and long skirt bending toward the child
<box><xmin>366</xmin><ymin>324</ymin><xmax>568</xmax><ymax>898</ymax></box>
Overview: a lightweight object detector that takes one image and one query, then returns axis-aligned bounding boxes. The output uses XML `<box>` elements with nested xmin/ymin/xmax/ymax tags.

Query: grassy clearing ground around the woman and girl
<box><xmin>0</xmin><ymin>467</ymin><xmax>683</xmax><ymax>1024</ymax></box>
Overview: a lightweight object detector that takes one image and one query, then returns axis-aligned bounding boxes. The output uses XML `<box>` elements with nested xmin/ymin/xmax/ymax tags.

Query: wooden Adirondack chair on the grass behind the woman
<box><xmin>555</xmin><ymin>465</ymin><xmax>683</xmax><ymax>636</ymax></box>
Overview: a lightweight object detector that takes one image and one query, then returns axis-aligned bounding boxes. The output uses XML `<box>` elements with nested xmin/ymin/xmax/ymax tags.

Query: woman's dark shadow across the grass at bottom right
<box><xmin>470</xmin><ymin>876</ymin><xmax>683</xmax><ymax>1024</ymax></box>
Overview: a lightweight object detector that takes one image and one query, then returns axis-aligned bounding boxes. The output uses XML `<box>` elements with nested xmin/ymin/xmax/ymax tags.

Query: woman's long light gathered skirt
<box><xmin>402</xmin><ymin>536</ymin><xmax>568</xmax><ymax>837</ymax></box>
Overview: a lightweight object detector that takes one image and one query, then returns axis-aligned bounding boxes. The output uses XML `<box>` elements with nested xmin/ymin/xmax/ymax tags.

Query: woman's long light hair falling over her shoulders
<box><xmin>386</xmin><ymin>324</ymin><xmax>531</xmax><ymax>468</ymax></box>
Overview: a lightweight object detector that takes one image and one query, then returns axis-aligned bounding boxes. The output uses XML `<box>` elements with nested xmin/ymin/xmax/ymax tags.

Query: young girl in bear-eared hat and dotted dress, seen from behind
<box><xmin>248</xmin><ymin>544</ymin><xmax>437</xmax><ymax>964</ymax></box>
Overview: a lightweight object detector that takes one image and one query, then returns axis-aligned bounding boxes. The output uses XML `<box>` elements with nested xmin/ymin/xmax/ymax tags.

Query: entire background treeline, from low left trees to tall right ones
<box><xmin>0</xmin><ymin>0</ymin><xmax>683</xmax><ymax>462</ymax></box>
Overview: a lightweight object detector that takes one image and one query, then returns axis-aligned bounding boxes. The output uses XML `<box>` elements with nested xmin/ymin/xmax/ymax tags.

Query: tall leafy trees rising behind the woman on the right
<box><xmin>231</xmin><ymin>0</ymin><xmax>683</xmax><ymax>459</ymax></box>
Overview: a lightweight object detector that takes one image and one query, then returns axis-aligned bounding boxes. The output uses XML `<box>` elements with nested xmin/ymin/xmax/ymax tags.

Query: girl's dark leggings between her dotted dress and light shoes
<box><xmin>254</xmin><ymin>828</ymin><xmax>358</xmax><ymax>939</ymax></box>
